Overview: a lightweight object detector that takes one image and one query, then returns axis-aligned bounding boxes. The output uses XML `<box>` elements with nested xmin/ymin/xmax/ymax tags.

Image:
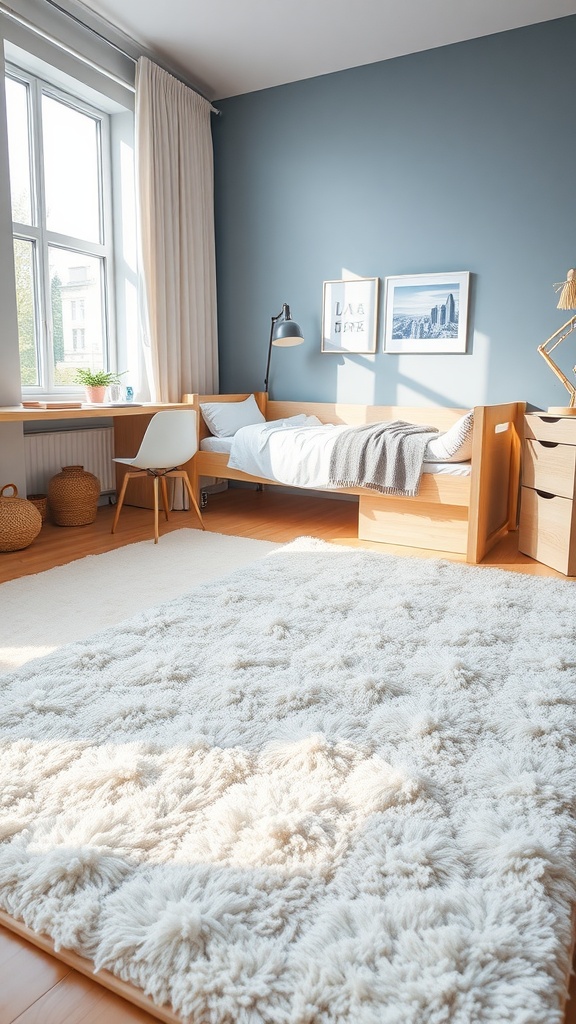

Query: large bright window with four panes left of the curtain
<box><xmin>6</xmin><ymin>66</ymin><xmax>112</xmax><ymax>393</ymax></box>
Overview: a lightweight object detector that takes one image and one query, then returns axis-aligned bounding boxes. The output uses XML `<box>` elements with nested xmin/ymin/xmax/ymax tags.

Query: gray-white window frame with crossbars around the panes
<box><xmin>4</xmin><ymin>59</ymin><xmax>117</xmax><ymax>397</ymax></box>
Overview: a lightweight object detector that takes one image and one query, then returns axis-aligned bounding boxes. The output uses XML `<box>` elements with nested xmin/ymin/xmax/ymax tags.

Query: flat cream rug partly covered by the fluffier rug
<box><xmin>0</xmin><ymin>529</ymin><xmax>279</xmax><ymax>674</ymax></box>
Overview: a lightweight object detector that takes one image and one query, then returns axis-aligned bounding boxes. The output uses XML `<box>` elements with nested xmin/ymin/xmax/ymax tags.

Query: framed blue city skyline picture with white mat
<box><xmin>384</xmin><ymin>270</ymin><xmax>470</xmax><ymax>354</ymax></box>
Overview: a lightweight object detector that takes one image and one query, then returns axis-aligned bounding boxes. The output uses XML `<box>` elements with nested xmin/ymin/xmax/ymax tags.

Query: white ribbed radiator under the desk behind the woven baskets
<box><xmin>25</xmin><ymin>427</ymin><xmax>116</xmax><ymax>495</ymax></box>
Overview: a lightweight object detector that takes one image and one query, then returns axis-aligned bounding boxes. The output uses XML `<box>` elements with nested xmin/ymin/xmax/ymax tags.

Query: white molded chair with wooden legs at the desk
<box><xmin>112</xmin><ymin>409</ymin><xmax>205</xmax><ymax>544</ymax></box>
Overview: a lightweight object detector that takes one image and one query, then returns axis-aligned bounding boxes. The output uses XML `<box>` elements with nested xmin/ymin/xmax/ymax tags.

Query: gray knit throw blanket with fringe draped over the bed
<box><xmin>329</xmin><ymin>420</ymin><xmax>438</xmax><ymax>498</ymax></box>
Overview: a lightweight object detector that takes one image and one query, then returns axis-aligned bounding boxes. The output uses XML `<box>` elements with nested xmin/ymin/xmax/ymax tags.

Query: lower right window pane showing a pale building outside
<box><xmin>48</xmin><ymin>246</ymin><xmax>107</xmax><ymax>384</ymax></box>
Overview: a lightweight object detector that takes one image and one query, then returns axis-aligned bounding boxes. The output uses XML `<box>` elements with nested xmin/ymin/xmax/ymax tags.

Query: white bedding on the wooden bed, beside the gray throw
<box><xmin>200</xmin><ymin>414</ymin><xmax>470</xmax><ymax>488</ymax></box>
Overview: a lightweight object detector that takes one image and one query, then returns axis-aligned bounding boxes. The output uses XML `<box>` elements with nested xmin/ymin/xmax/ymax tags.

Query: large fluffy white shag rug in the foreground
<box><xmin>0</xmin><ymin>539</ymin><xmax>576</xmax><ymax>1024</ymax></box>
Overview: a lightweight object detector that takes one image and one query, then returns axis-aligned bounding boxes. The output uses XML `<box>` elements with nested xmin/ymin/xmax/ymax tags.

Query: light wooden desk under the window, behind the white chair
<box><xmin>0</xmin><ymin>402</ymin><xmax>191</xmax><ymax>508</ymax></box>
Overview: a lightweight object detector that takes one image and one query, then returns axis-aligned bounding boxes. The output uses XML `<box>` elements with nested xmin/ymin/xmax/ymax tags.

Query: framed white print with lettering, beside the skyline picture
<box><xmin>321</xmin><ymin>278</ymin><xmax>380</xmax><ymax>355</ymax></box>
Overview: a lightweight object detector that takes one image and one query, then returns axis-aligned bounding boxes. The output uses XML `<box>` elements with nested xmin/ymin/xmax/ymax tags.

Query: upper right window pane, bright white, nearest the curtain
<box><xmin>42</xmin><ymin>95</ymin><xmax>102</xmax><ymax>242</ymax></box>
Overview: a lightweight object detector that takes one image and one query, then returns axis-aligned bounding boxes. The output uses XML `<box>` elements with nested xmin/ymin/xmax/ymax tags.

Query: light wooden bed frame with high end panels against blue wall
<box><xmin>182</xmin><ymin>391</ymin><xmax>525</xmax><ymax>564</ymax></box>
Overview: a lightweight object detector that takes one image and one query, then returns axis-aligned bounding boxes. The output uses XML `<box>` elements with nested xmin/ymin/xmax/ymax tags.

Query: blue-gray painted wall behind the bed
<box><xmin>213</xmin><ymin>16</ymin><xmax>576</xmax><ymax>408</ymax></box>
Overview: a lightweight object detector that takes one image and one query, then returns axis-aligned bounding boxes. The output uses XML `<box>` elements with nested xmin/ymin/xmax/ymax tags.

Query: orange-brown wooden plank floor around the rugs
<box><xmin>0</xmin><ymin>488</ymin><xmax>576</xmax><ymax>1024</ymax></box>
